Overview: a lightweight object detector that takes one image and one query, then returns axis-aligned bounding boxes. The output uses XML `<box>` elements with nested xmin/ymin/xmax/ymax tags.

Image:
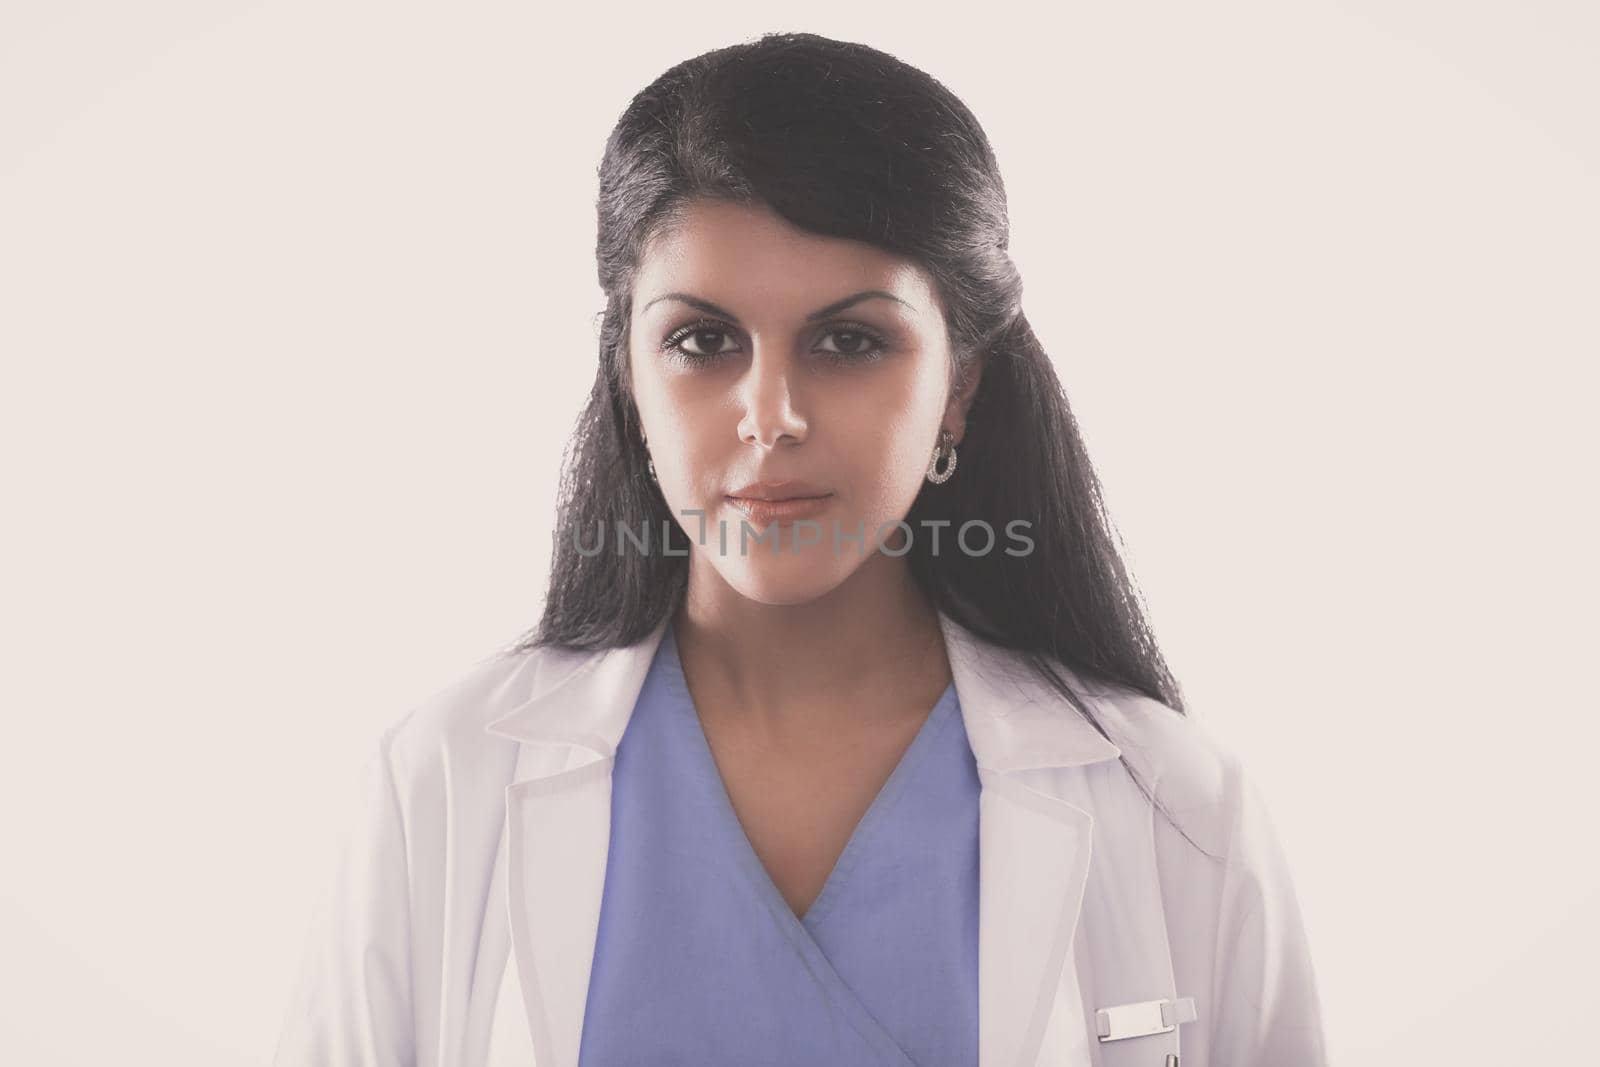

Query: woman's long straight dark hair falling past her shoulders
<box><xmin>510</xmin><ymin>34</ymin><xmax>1184</xmax><ymax>831</ymax></box>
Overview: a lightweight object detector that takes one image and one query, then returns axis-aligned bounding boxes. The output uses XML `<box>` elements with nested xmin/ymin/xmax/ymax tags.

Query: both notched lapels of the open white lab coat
<box><xmin>486</xmin><ymin>614</ymin><xmax>1118</xmax><ymax>1067</ymax></box>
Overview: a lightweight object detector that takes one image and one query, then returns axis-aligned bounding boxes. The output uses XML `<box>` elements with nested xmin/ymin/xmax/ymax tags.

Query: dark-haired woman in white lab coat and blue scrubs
<box><xmin>278</xmin><ymin>34</ymin><xmax>1325</xmax><ymax>1067</ymax></box>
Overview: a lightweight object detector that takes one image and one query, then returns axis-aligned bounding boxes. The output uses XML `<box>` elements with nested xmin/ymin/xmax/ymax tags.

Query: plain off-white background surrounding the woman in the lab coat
<box><xmin>0</xmin><ymin>0</ymin><xmax>1600</xmax><ymax>1065</ymax></box>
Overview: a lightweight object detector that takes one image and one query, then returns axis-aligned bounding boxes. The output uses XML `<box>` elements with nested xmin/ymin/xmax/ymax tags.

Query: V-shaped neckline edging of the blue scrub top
<box><xmin>662</xmin><ymin>625</ymin><xmax>955</xmax><ymax>944</ymax></box>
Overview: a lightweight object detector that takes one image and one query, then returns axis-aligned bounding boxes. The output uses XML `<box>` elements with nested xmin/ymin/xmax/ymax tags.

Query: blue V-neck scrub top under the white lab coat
<box><xmin>579</xmin><ymin>625</ymin><xmax>979</xmax><ymax>1067</ymax></box>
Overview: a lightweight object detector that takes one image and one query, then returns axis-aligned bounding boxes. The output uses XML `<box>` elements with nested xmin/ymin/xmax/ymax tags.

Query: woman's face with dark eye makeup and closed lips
<box><xmin>629</xmin><ymin>200</ymin><xmax>976</xmax><ymax>603</ymax></box>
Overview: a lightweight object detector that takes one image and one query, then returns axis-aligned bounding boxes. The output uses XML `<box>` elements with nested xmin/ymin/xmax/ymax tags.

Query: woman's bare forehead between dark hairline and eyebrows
<box><xmin>634</xmin><ymin>200</ymin><xmax>934</xmax><ymax>314</ymax></box>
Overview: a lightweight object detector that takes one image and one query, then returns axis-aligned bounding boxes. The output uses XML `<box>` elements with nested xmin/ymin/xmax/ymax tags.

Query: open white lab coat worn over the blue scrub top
<box><xmin>275</xmin><ymin>614</ymin><xmax>1326</xmax><ymax>1067</ymax></box>
